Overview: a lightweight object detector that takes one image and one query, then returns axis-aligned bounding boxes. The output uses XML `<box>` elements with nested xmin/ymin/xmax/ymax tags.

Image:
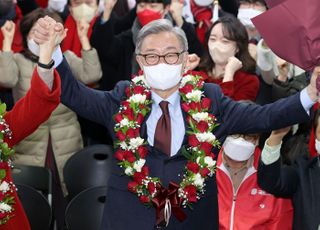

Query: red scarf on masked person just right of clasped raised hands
<box><xmin>62</xmin><ymin>15</ymin><xmax>97</xmax><ymax>57</ymax></box>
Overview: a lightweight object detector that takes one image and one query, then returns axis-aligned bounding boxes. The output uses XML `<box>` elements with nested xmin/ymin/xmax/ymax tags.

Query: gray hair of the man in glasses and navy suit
<box><xmin>135</xmin><ymin>19</ymin><xmax>188</xmax><ymax>54</ymax></box>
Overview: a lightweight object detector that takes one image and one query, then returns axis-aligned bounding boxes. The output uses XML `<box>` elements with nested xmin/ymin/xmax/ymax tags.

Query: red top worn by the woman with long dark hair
<box><xmin>200</xmin><ymin>71</ymin><xmax>260</xmax><ymax>101</ymax></box>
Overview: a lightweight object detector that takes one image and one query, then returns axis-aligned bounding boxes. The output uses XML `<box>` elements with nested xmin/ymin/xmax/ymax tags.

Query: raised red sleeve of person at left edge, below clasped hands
<box><xmin>4</xmin><ymin>69</ymin><xmax>61</xmax><ymax>146</ymax></box>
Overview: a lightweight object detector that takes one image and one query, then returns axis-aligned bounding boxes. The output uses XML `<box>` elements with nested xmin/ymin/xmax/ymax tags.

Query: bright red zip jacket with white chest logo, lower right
<box><xmin>216</xmin><ymin>148</ymin><xmax>293</xmax><ymax>230</ymax></box>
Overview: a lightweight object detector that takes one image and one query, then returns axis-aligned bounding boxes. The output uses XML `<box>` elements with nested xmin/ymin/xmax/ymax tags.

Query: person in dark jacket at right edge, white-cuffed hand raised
<box><xmin>258</xmin><ymin>109</ymin><xmax>320</xmax><ymax>230</ymax></box>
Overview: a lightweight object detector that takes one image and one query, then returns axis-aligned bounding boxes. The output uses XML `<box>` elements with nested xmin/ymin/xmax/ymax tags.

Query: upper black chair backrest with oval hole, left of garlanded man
<box><xmin>63</xmin><ymin>145</ymin><xmax>113</xmax><ymax>200</ymax></box>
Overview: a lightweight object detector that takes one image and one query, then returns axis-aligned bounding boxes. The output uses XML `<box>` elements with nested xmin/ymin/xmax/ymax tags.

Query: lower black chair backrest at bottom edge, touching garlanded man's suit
<box><xmin>65</xmin><ymin>186</ymin><xmax>107</xmax><ymax>230</ymax></box>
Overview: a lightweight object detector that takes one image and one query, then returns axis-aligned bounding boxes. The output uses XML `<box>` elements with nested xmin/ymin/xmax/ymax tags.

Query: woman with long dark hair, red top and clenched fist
<box><xmin>199</xmin><ymin>15</ymin><xmax>259</xmax><ymax>101</ymax></box>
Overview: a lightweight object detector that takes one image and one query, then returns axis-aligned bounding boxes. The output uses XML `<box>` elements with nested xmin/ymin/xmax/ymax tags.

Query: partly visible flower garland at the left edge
<box><xmin>0</xmin><ymin>104</ymin><xmax>16</xmax><ymax>225</ymax></box>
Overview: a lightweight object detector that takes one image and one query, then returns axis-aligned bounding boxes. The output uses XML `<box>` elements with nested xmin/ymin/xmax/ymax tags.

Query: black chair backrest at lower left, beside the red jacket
<box><xmin>12</xmin><ymin>165</ymin><xmax>52</xmax><ymax>205</ymax></box>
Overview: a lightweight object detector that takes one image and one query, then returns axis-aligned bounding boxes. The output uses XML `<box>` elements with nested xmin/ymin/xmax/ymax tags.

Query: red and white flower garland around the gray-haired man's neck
<box><xmin>114</xmin><ymin>74</ymin><xmax>220</xmax><ymax>215</ymax></box>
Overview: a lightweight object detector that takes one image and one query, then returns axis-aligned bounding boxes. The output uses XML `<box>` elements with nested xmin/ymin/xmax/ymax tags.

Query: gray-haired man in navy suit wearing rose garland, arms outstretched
<box><xmin>34</xmin><ymin>17</ymin><xmax>320</xmax><ymax>230</ymax></box>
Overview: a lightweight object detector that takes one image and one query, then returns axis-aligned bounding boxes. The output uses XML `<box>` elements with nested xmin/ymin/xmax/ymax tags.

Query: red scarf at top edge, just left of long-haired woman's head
<box><xmin>190</xmin><ymin>0</ymin><xmax>212</xmax><ymax>45</ymax></box>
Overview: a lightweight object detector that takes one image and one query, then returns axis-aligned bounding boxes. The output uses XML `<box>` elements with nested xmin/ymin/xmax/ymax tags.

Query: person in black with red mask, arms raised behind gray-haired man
<box><xmin>91</xmin><ymin>0</ymin><xmax>202</xmax><ymax>90</ymax></box>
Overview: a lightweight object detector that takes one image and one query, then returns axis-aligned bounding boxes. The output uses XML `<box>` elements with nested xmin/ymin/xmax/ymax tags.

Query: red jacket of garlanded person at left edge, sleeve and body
<box><xmin>0</xmin><ymin>70</ymin><xmax>60</xmax><ymax>230</ymax></box>
